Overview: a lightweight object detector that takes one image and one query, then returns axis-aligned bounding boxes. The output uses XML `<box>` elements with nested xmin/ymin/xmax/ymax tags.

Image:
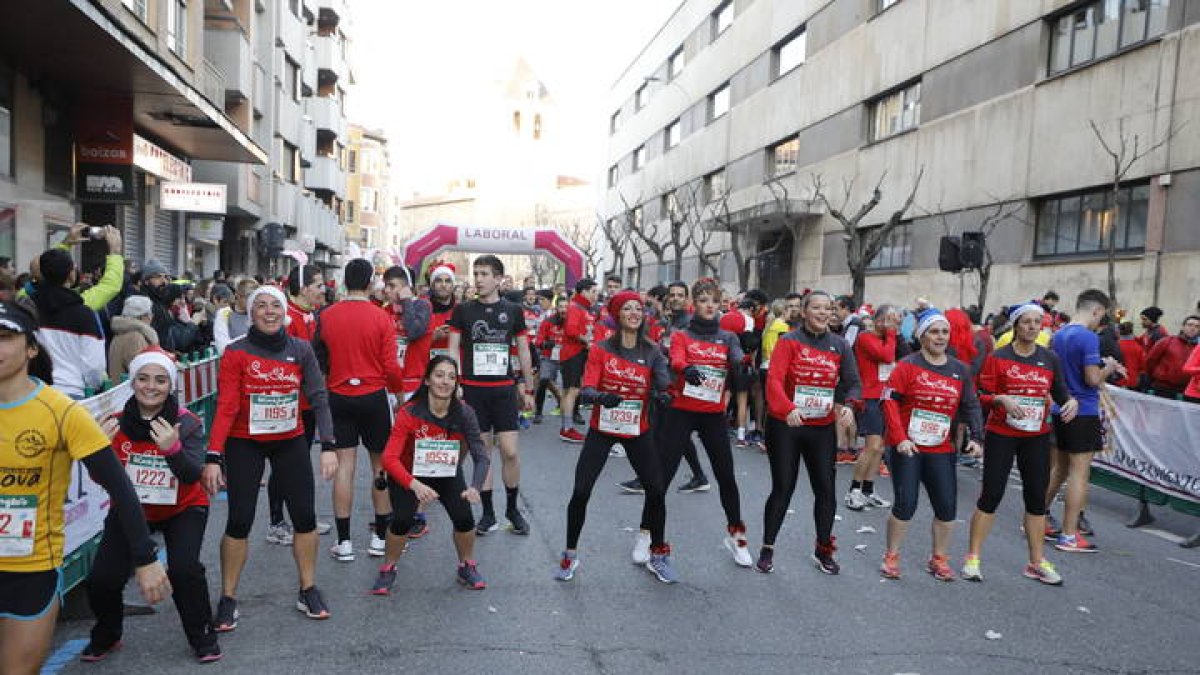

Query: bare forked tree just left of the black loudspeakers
<box><xmin>812</xmin><ymin>166</ymin><xmax>925</xmax><ymax>304</ymax></box>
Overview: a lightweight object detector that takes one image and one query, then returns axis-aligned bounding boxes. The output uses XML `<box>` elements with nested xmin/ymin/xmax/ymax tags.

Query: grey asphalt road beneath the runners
<box><xmin>48</xmin><ymin>425</ymin><xmax>1200</xmax><ymax>675</ymax></box>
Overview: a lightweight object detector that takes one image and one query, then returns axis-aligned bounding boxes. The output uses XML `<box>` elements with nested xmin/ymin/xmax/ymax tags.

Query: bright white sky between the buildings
<box><xmin>347</xmin><ymin>0</ymin><xmax>680</xmax><ymax>195</ymax></box>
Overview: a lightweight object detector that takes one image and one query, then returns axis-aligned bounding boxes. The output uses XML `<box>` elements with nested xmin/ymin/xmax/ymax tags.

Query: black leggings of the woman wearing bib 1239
<box><xmin>566</xmin><ymin>429</ymin><xmax>678</xmax><ymax>550</ymax></box>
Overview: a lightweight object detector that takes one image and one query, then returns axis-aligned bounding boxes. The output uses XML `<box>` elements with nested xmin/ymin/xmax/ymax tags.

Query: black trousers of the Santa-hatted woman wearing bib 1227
<box><xmin>86</xmin><ymin>507</ymin><xmax>217</xmax><ymax>649</ymax></box>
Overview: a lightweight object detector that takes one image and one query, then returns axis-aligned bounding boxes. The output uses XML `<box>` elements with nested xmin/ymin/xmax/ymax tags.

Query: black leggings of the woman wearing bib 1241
<box><xmin>762</xmin><ymin>417</ymin><xmax>838</xmax><ymax>546</ymax></box>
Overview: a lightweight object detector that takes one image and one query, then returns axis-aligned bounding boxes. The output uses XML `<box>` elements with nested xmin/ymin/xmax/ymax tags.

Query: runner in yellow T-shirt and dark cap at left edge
<box><xmin>0</xmin><ymin>303</ymin><xmax>172</xmax><ymax>675</ymax></box>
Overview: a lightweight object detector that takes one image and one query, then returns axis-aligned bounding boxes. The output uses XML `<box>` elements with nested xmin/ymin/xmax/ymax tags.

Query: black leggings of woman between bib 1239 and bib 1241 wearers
<box><xmin>642</xmin><ymin>408</ymin><xmax>742</xmax><ymax>528</ymax></box>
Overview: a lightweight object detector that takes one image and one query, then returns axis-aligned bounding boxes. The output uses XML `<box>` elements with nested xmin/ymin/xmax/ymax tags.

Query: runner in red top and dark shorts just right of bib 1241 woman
<box><xmin>846</xmin><ymin>305</ymin><xmax>900</xmax><ymax>510</ymax></box>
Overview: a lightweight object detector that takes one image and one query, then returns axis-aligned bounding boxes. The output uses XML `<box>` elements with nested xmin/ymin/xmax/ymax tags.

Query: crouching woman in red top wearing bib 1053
<box><xmin>371</xmin><ymin>357</ymin><xmax>491</xmax><ymax>596</ymax></box>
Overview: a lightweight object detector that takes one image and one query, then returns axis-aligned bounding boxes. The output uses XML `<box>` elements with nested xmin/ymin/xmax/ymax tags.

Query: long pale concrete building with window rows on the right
<box><xmin>609</xmin><ymin>0</ymin><xmax>1200</xmax><ymax>323</ymax></box>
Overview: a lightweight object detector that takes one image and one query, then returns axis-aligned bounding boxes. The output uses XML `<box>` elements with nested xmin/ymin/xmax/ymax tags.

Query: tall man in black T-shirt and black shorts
<box><xmin>448</xmin><ymin>256</ymin><xmax>536</xmax><ymax>534</ymax></box>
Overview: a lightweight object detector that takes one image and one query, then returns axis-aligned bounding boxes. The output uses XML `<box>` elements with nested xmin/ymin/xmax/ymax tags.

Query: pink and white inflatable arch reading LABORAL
<box><xmin>404</xmin><ymin>223</ymin><xmax>583</xmax><ymax>282</ymax></box>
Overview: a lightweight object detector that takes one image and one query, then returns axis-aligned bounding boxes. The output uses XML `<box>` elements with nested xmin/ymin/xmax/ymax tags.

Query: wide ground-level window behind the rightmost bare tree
<box><xmin>1033</xmin><ymin>183</ymin><xmax>1150</xmax><ymax>257</ymax></box>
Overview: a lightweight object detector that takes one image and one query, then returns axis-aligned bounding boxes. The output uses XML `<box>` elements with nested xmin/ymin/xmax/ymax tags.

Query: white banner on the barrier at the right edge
<box><xmin>1092</xmin><ymin>387</ymin><xmax>1200</xmax><ymax>503</ymax></box>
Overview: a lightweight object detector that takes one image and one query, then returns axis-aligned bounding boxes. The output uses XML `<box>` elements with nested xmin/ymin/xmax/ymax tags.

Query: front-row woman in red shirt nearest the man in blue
<box><xmin>962</xmin><ymin>303</ymin><xmax>1079</xmax><ymax>585</ymax></box>
